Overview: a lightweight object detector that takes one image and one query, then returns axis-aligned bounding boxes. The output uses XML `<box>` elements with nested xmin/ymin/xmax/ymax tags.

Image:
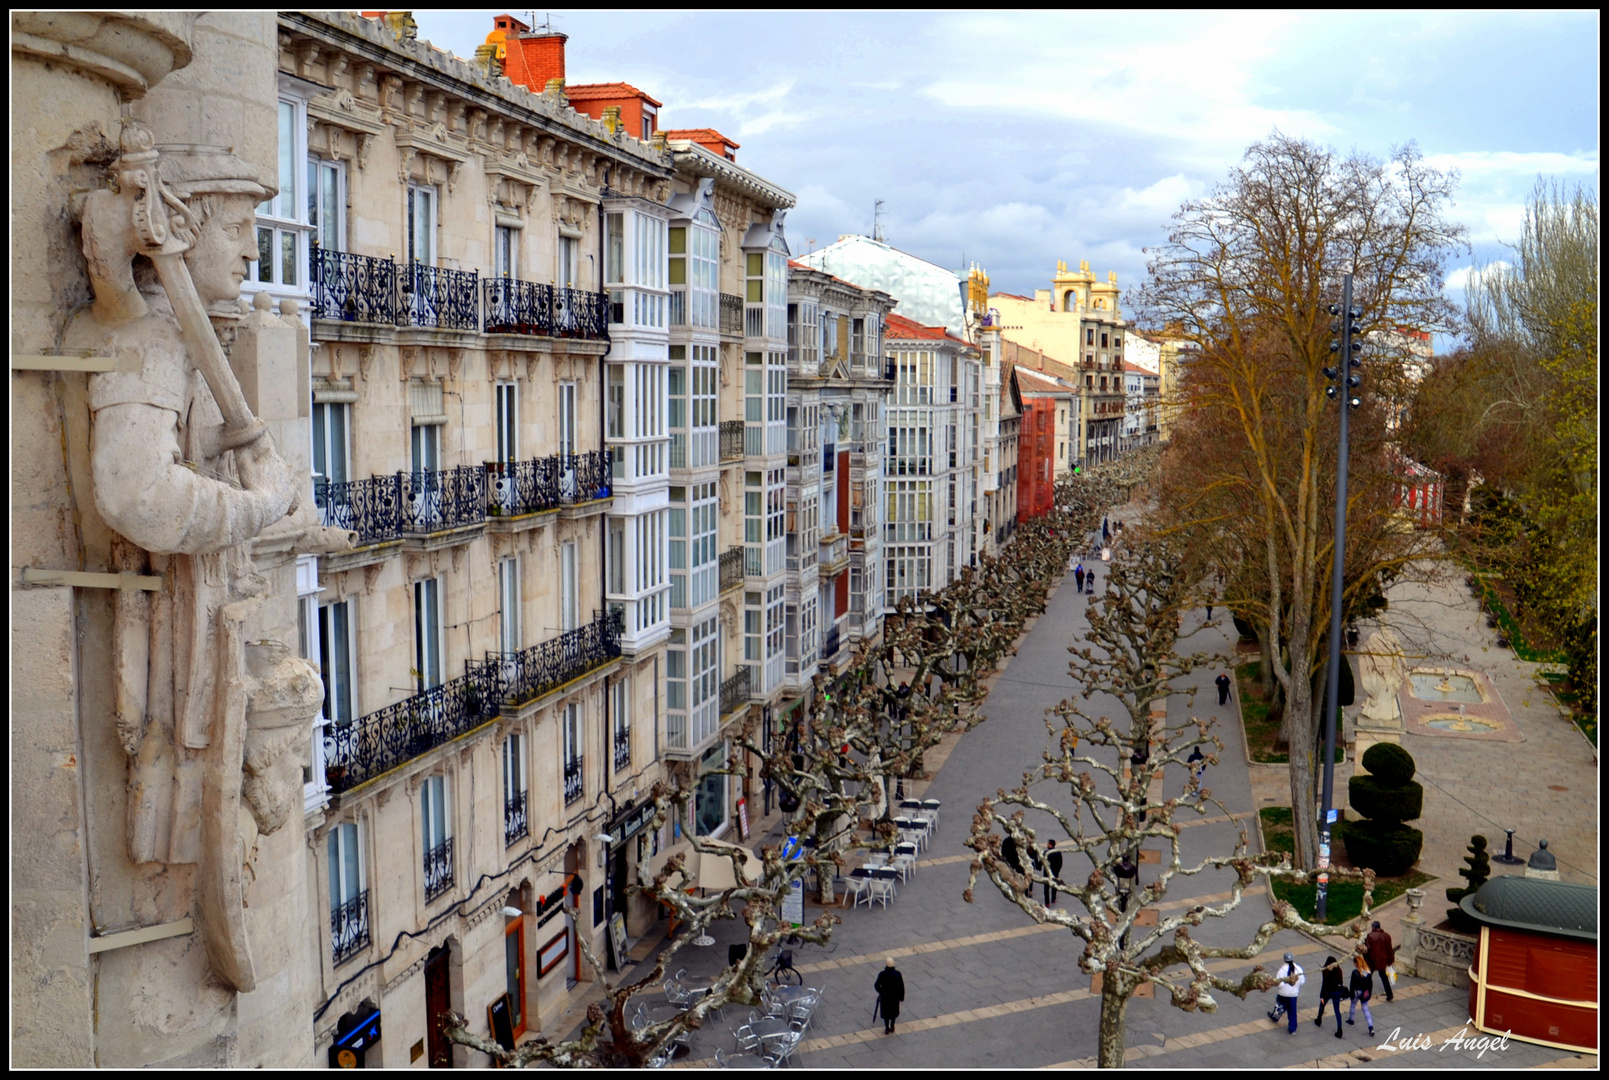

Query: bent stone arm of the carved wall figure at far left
<box><xmin>93</xmin><ymin>402</ymin><xmax>294</xmax><ymax>554</ymax></box>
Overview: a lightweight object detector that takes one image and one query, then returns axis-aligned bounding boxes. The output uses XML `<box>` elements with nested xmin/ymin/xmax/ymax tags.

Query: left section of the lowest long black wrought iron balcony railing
<box><xmin>313</xmin><ymin>671</ymin><xmax>499</xmax><ymax>794</ymax></box>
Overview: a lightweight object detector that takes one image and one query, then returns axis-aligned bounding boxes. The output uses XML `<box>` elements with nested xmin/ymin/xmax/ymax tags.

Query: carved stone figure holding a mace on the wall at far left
<box><xmin>69</xmin><ymin>124</ymin><xmax>344</xmax><ymax>991</ymax></box>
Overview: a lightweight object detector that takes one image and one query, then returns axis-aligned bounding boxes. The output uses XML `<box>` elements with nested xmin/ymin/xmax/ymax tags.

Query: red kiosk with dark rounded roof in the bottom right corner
<box><xmin>1459</xmin><ymin>877</ymin><xmax>1598</xmax><ymax>1053</ymax></box>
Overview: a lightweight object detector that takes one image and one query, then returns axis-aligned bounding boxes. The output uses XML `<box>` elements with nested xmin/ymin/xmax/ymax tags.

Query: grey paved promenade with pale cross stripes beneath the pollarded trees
<box><xmin>559</xmin><ymin>511</ymin><xmax>1596</xmax><ymax>1069</ymax></box>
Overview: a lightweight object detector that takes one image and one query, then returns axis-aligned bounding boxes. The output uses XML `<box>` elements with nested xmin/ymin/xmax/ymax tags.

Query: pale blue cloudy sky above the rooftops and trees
<box><xmin>415</xmin><ymin>10</ymin><xmax>1599</xmax><ymax>331</ymax></box>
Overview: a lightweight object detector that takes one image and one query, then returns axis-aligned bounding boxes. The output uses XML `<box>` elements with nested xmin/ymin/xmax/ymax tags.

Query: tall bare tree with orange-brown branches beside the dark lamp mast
<box><xmin>1138</xmin><ymin>132</ymin><xmax>1464</xmax><ymax>866</ymax></box>
